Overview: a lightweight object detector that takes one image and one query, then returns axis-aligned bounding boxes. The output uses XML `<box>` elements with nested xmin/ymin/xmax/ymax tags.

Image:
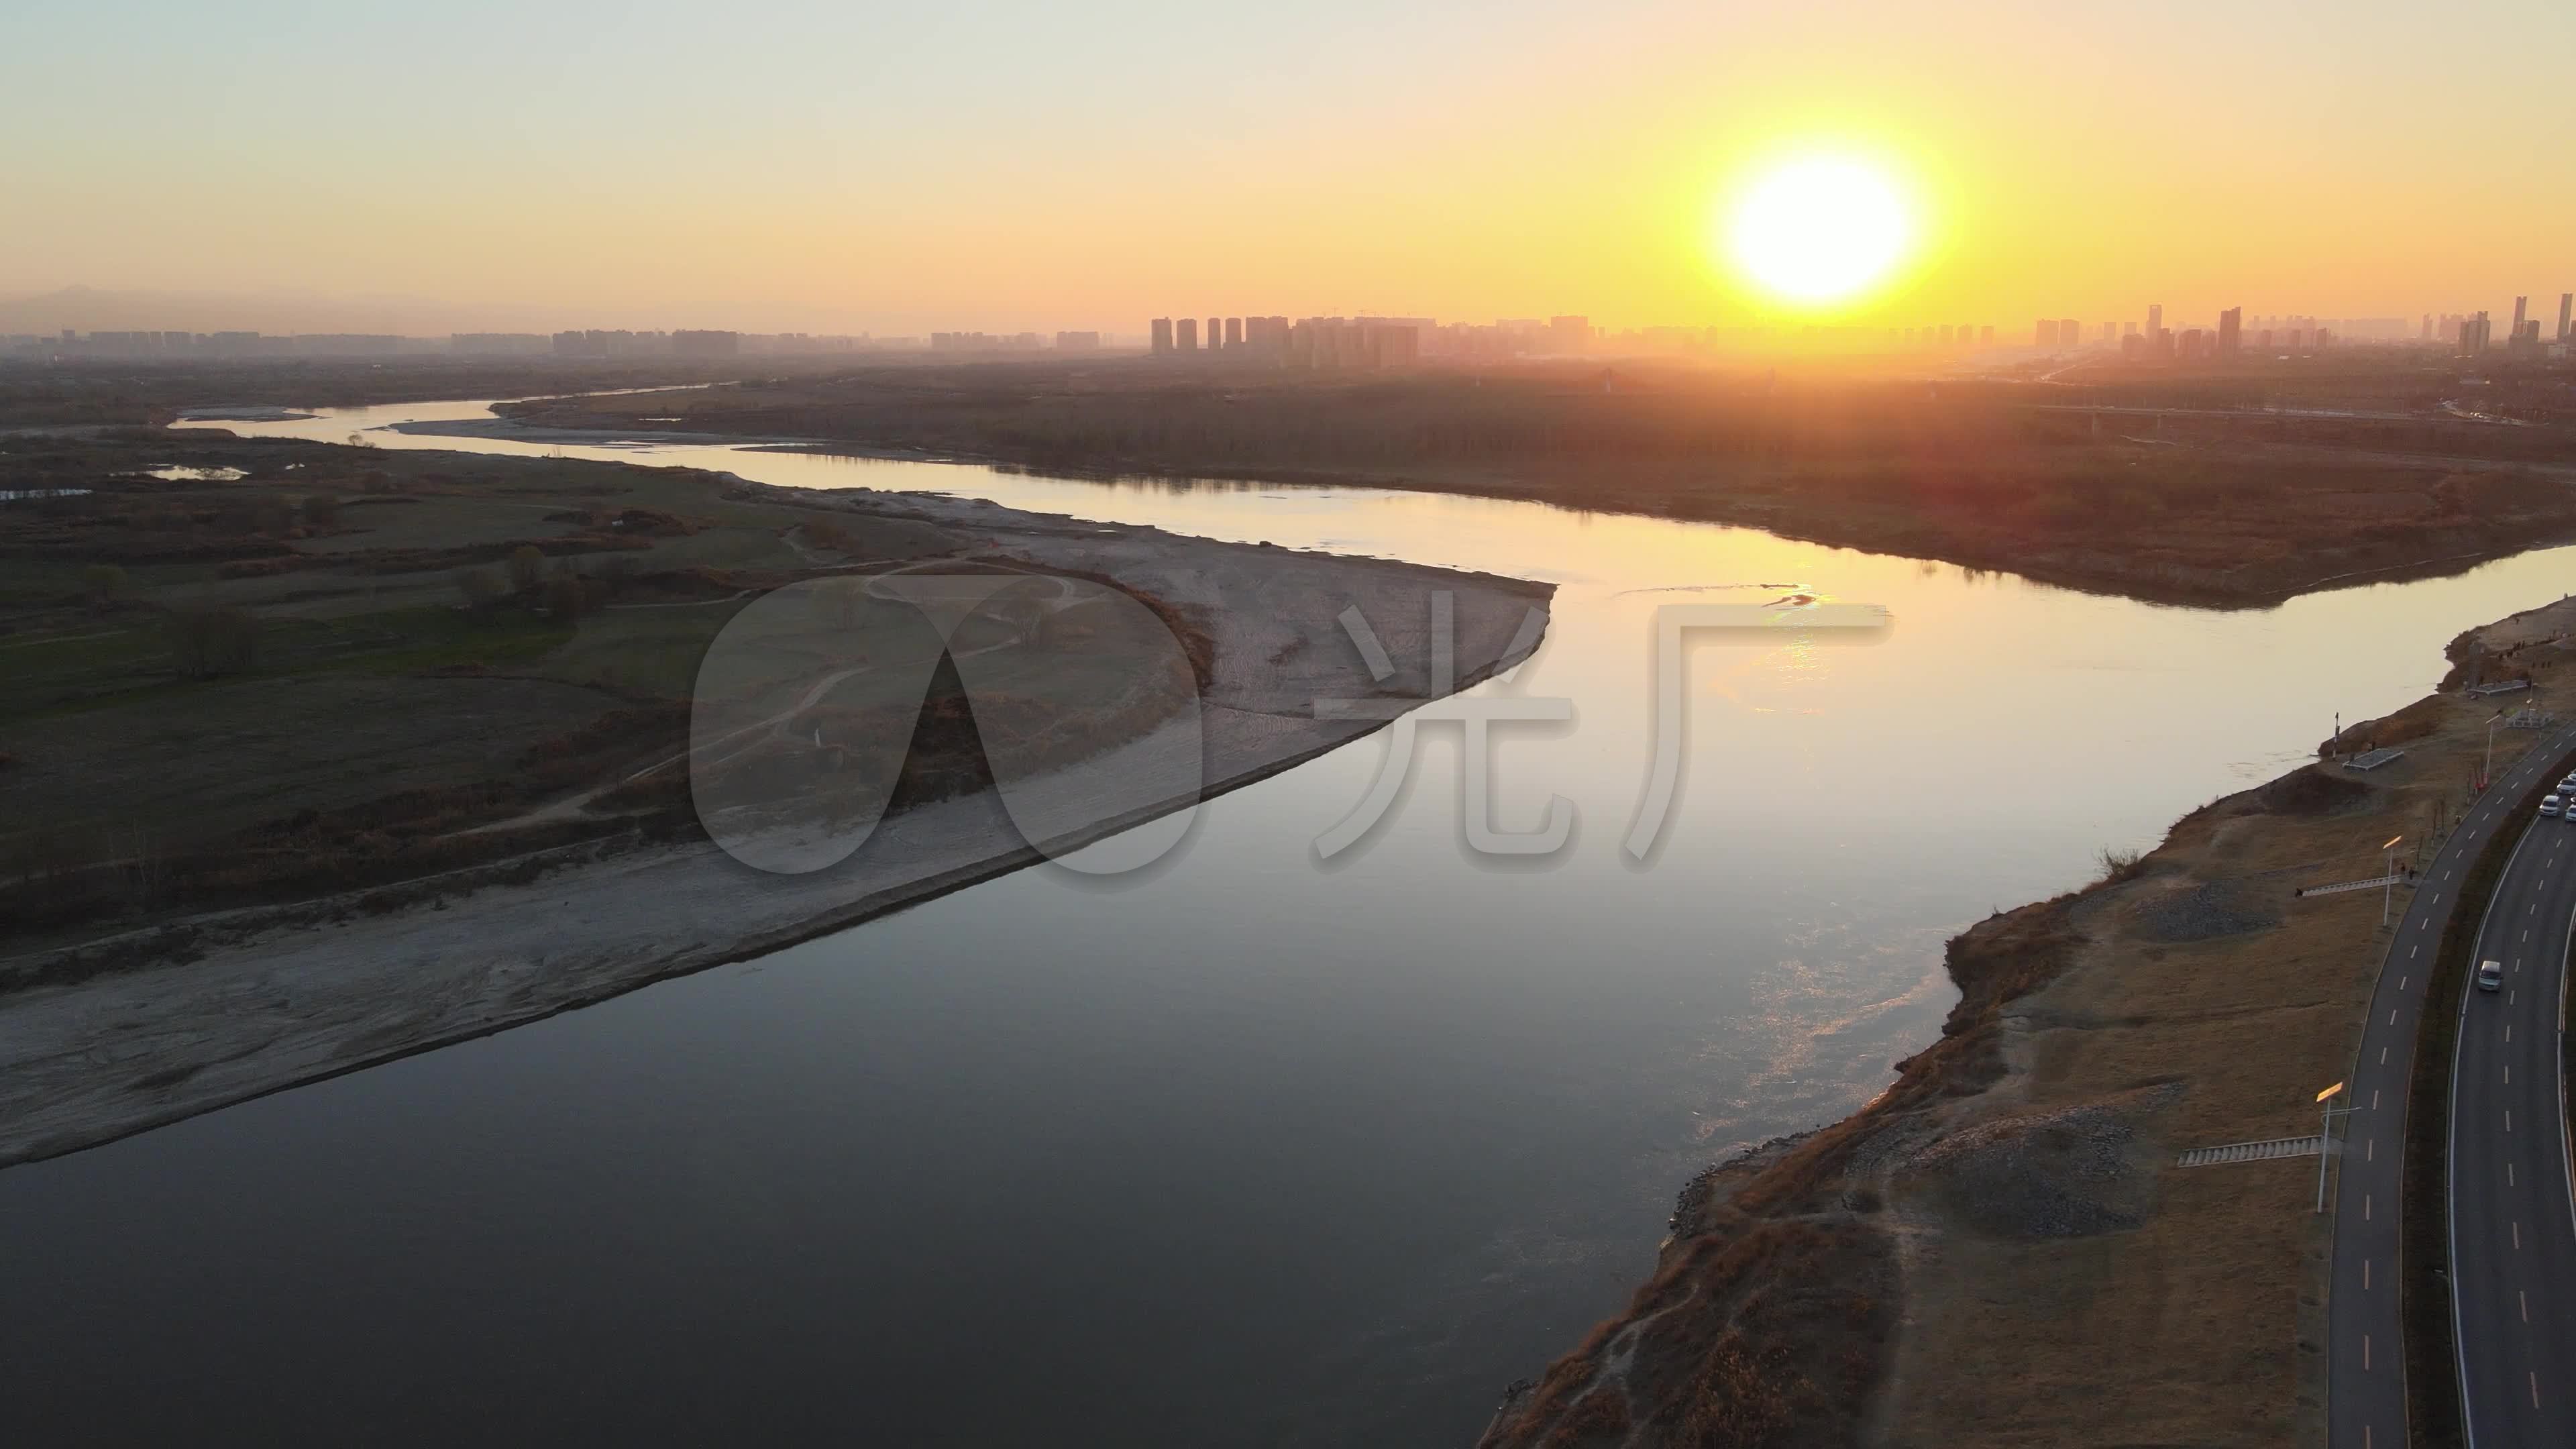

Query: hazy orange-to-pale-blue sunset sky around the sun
<box><xmin>20</xmin><ymin>0</ymin><xmax>2576</xmax><ymax>333</ymax></box>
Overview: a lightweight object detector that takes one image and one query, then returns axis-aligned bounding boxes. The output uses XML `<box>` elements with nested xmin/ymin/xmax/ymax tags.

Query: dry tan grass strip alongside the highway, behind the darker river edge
<box><xmin>1883</xmin><ymin>680</ymin><xmax>2555</xmax><ymax>1446</ymax></box>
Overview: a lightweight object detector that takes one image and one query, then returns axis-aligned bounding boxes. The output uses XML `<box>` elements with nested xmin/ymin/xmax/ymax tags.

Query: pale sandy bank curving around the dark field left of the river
<box><xmin>0</xmin><ymin>482</ymin><xmax>1551</xmax><ymax>1165</ymax></box>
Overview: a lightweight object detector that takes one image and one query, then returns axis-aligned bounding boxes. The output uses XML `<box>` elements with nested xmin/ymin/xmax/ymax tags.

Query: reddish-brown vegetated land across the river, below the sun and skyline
<box><xmin>500</xmin><ymin>361</ymin><xmax>2576</xmax><ymax>606</ymax></box>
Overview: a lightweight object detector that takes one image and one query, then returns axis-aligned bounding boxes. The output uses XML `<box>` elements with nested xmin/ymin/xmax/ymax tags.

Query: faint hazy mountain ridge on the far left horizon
<box><xmin>0</xmin><ymin>286</ymin><xmax>541</xmax><ymax>337</ymax></box>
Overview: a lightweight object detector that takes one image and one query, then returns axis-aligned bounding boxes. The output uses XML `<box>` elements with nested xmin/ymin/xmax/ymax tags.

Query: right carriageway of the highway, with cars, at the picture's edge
<box><xmin>2450</xmin><ymin>784</ymin><xmax>2576</xmax><ymax>1446</ymax></box>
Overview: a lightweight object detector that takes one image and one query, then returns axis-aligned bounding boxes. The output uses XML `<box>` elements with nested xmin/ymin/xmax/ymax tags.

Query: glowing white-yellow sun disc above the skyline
<box><xmin>1729</xmin><ymin>157</ymin><xmax>1914</xmax><ymax>305</ymax></box>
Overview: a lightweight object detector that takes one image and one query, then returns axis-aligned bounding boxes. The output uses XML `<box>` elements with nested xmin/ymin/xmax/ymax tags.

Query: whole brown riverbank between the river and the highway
<box><xmin>1484</xmin><ymin>592</ymin><xmax>2576</xmax><ymax>1449</ymax></box>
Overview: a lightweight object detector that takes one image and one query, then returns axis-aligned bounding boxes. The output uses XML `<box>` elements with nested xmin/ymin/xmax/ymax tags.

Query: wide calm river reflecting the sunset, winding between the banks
<box><xmin>0</xmin><ymin>402</ymin><xmax>2576</xmax><ymax>1446</ymax></box>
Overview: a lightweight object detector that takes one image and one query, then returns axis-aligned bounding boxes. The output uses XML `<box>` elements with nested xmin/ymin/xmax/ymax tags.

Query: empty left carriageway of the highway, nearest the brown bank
<box><xmin>2318</xmin><ymin>727</ymin><xmax>2576</xmax><ymax>1449</ymax></box>
